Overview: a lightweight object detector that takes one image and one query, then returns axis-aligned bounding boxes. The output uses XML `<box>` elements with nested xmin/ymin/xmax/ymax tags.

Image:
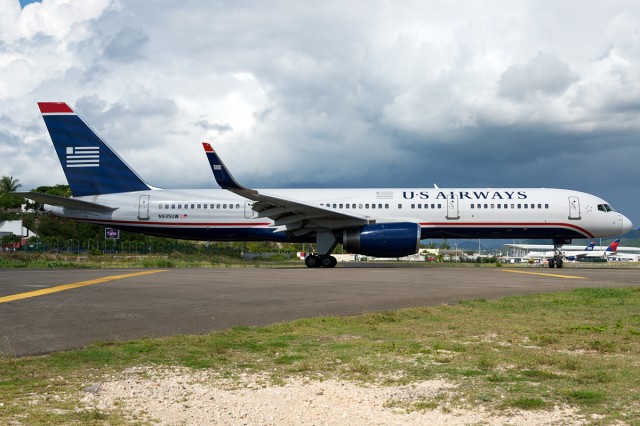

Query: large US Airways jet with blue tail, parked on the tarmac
<box><xmin>19</xmin><ymin>102</ymin><xmax>632</xmax><ymax>268</ymax></box>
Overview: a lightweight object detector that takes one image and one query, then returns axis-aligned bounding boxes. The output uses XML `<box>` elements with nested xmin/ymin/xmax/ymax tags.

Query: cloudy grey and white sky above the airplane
<box><xmin>0</xmin><ymin>0</ymin><xmax>640</xmax><ymax>227</ymax></box>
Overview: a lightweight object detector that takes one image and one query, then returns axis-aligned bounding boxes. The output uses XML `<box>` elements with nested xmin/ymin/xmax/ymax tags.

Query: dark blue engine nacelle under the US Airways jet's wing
<box><xmin>342</xmin><ymin>222</ymin><xmax>420</xmax><ymax>257</ymax></box>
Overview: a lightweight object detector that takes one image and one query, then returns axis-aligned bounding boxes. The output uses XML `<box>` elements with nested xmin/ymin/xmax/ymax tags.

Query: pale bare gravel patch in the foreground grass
<box><xmin>82</xmin><ymin>367</ymin><xmax>586</xmax><ymax>425</ymax></box>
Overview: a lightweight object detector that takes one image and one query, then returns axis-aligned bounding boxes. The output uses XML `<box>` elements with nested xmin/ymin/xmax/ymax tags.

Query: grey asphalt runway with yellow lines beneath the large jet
<box><xmin>0</xmin><ymin>266</ymin><xmax>640</xmax><ymax>356</ymax></box>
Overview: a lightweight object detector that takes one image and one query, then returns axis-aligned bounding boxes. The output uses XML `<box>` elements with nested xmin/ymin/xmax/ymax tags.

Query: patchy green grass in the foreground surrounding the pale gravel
<box><xmin>0</xmin><ymin>288</ymin><xmax>640</xmax><ymax>424</ymax></box>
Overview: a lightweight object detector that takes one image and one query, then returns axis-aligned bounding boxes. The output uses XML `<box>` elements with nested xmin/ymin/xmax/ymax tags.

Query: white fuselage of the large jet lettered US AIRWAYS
<box><xmin>46</xmin><ymin>188</ymin><xmax>632</xmax><ymax>242</ymax></box>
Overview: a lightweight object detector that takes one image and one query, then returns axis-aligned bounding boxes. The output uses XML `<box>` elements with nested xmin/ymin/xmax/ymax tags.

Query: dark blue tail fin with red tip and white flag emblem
<box><xmin>38</xmin><ymin>102</ymin><xmax>151</xmax><ymax>197</ymax></box>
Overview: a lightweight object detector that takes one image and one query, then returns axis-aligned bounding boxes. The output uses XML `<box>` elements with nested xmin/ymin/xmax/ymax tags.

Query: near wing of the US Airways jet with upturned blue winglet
<box><xmin>202</xmin><ymin>142</ymin><xmax>375</xmax><ymax>235</ymax></box>
